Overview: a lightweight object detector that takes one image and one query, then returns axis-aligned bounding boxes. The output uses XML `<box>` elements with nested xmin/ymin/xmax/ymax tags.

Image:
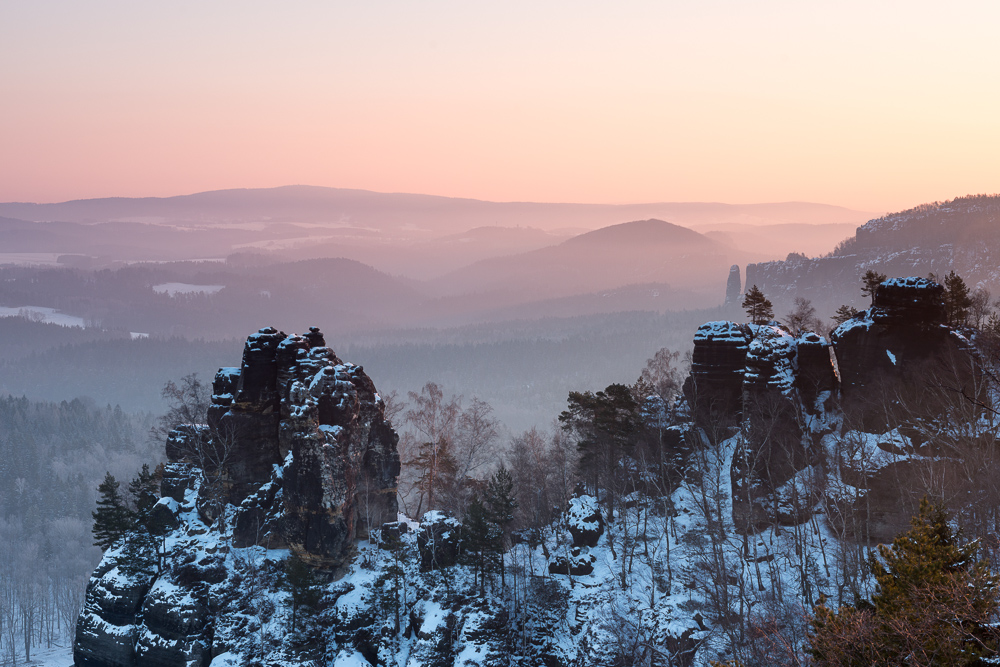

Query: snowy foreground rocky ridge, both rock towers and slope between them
<box><xmin>74</xmin><ymin>290</ymin><xmax>975</xmax><ymax>667</ymax></box>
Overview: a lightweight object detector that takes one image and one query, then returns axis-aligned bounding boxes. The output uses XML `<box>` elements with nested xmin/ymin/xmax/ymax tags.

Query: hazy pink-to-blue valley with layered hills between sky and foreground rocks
<box><xmin>0</xmin><ymin>187</ymin><xmax>866</xmax><ymax>430</ymax></box>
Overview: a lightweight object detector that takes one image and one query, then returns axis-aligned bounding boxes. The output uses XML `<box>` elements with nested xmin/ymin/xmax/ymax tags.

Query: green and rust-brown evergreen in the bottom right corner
<box><xmin>809</xmin><ymin>499</ymin><xmax>1000</xmax><ymax>667</ymax></box>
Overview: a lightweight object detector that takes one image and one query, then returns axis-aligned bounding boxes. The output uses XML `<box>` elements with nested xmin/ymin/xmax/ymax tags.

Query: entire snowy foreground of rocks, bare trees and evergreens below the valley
<box><xmin>52</xmin><ymin>274</ymin><xmax>1000</xmax><ymax>666</ymax></box>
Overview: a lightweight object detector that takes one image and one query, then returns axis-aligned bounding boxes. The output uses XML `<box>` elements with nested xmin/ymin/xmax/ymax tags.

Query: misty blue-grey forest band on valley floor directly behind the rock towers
<box><xmin>0</xmin><ymin>311</ymin><xmax>704</xmax><ymax>431</ymax></box>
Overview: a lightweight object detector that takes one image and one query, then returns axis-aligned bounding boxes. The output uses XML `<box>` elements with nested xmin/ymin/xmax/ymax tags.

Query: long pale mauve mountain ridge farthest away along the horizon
<box><xmin>0</xmin><ymin>185</ymin><xmax>871</xmax><ymax>233</ymax></box>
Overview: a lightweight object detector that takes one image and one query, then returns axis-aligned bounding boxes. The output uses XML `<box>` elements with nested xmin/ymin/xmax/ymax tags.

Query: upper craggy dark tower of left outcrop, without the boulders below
<box><xmin>167</xmin><ymin>327</ymin><xmax>399</xmax><ymax>569</ymax></box>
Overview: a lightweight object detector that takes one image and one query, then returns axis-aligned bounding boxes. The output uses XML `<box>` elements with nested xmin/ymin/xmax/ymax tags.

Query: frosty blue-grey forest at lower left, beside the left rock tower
<box><xmin>0</xmin><ymin>397</ymin><xmax>156</xmax><ymax>665</ymax></box>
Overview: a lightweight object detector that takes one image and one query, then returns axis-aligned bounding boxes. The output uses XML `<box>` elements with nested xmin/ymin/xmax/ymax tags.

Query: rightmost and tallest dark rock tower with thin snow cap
<box><xmin>828</xmin><ymin>278</ymin><xmax>984</xmax><ymax>541</ymax></box>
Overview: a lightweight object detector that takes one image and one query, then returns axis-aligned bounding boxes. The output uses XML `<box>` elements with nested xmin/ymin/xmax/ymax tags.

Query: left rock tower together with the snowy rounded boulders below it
<box><xmin>74</xmin><ymin>327</ymin><xmax>399</xmax><ymax>667</ymax></box>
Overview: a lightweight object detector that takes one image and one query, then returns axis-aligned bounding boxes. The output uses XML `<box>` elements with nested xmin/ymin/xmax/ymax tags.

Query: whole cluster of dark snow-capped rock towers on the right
<box><xmin>685</xmin><ymin>278</ymin><xmax>981</xmax><ymax>539</ymax></box>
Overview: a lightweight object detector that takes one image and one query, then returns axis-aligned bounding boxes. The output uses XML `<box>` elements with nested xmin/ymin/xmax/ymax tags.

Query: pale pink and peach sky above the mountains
<box><xmin>0</xmin><ymin>0</ymin><xmax>1000</xmax><ymax>212</ymax></box>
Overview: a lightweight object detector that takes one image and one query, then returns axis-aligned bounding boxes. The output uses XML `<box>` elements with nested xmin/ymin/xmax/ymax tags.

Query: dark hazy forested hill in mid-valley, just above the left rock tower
<box><xmin>0</xmin><ymin>259</ymin><xmax>420</xmax><ymax>338</ymax></box>
